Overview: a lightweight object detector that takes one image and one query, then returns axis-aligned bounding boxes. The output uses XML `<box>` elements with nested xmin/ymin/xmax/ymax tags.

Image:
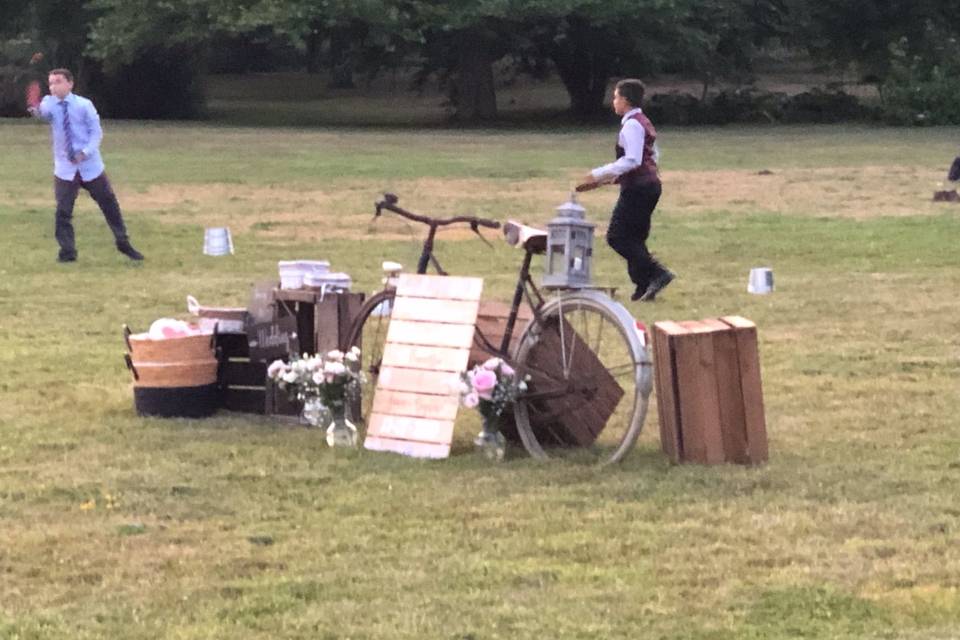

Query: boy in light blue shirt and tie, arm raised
<box><xmin>29</xmin><ymin>69</ymin><xmax>143</xmax><ymax>262</ymax></box>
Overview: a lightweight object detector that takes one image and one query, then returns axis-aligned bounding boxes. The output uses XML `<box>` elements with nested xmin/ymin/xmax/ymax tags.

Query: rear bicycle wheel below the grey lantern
<box><xmin>514</xmin><ymin>290</ymin><xmax>653</xmax><ymax>464</ymax></box>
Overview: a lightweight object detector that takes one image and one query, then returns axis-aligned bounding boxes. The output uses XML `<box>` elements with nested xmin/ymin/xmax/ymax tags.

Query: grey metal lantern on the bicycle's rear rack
<box><xmin>543</xmin><ymin>193</ymin><xmax>595</xmax><ymax>289</ymax></box>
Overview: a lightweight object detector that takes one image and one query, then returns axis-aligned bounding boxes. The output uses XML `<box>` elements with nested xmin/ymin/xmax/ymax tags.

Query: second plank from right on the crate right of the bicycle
<box><xmin>703</xmin><ymin>319</ymin><xmax>749</xmax><ymax>464</ymax></box>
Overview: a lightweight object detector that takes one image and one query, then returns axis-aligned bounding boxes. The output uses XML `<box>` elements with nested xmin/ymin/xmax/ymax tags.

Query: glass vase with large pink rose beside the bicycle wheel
<box><xmin>460</xmin><ymin>358</ymin><xmax>527</xmax><ymax>461</ymax></box>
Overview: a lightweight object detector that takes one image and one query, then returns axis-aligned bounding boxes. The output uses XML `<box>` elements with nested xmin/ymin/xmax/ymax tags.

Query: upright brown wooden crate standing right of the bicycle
<box><xmin>653</xmin><ymin>316</ymin><xmax>768</xmax><ymax>464</ymax></box>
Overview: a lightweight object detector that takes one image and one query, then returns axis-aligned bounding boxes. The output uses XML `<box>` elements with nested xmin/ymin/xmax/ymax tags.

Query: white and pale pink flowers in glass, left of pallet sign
<box><xmin>267</xmin><ymin>347</ymin><xmax>364</xmax><ymax>447</ymax></box>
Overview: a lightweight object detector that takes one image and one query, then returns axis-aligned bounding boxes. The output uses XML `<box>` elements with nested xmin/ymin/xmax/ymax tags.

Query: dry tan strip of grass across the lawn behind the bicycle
<box><xmin>114</xmin><ymin>166</ymin><xmax>955</xmax><ymax>240</ymax></box>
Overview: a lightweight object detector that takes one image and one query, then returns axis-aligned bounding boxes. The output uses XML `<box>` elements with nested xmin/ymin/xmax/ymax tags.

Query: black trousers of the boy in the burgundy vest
<box><xmin>607</xmin><ymin>181</ymin><xmax>666</xmax><ymax>290</ymax></box>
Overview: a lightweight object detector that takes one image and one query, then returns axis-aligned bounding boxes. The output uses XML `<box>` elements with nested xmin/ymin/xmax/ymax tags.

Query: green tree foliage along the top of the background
<box><xmin>0</xmin><ymin>0</ymin><xmax>960</xmax><ymax>122</ymax></box>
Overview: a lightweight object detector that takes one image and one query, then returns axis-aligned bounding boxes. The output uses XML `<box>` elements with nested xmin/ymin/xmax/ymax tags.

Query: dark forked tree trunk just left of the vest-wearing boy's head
<box><xmin>550</xmin><ymin>16</ymin><xmax>614</xmax><ymax>121</ymax></box>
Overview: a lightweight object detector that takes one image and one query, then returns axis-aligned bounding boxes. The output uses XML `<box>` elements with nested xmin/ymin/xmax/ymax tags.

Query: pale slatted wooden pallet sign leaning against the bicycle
<box><xmin>363</xmin><ymin>274</ymin><xmax>483</xmax><ymax>458</ymax></box>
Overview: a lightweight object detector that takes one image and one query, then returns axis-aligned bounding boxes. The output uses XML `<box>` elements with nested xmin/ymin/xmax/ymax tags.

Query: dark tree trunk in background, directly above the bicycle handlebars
<box><xmin>453</xmin><ymin>29</ymin><xmax>497</xmax><ymax>122</ymax></box>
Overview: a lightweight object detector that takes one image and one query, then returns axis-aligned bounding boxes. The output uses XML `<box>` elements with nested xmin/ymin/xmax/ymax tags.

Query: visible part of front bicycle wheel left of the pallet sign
<box><xmin>344</xmin><ymin>289</ymin><xmax>396</xmax><ymax>427</ymax></box>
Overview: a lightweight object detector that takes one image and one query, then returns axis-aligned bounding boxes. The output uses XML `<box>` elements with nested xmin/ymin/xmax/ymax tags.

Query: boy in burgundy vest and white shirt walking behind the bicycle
<box><xmin>586</xmin><ymin>79</ymin><xmax>674</xmax><ymax>302</ymax></box>
